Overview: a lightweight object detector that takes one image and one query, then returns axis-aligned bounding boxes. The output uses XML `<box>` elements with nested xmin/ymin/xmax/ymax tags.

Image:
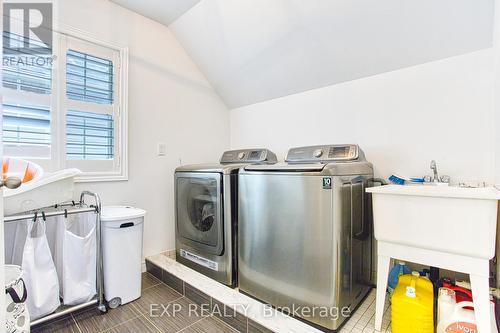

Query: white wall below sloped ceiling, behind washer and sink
<box><xmin>231</xmin><ymin>49</ymin><xmax>494</xmax><ymax>181</ymax></box>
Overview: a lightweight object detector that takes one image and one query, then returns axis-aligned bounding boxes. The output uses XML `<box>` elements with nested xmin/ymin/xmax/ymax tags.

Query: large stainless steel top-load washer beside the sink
<box><xmin>238</xmin><ymin>145</ymin><xmax>373</xmax><ymax>330</ymax></box>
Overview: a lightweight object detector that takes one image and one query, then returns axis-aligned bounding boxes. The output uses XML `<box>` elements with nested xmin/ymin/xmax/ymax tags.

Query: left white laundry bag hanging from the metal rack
<box><xmin>22</xmin><ymin>219</ymin><xmax>61</xmax><ymax>320</ymax></box>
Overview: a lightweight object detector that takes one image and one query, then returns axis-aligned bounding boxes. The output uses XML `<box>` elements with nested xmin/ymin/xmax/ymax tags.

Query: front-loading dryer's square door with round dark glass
<box><xmin>177</xmin><ymin>173</ymin><xmax>222</xmax><ymax>252</ymax></box>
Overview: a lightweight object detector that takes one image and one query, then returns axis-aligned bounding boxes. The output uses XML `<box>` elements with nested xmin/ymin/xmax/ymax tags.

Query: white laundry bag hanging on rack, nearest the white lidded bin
<box><xmin>55</xmin><ymin>212</ymin><xmax>97</xmax><ymax>305</ymax></box>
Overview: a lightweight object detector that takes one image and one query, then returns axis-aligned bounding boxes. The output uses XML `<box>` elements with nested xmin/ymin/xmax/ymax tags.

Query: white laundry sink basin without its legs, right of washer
<box><xmin>367</xmin><ymin>185</ymin><xmax>500</xmax><ymax>259</ymax></box>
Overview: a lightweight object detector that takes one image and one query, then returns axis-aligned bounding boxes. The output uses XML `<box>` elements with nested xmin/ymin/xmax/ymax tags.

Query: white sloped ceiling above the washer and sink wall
<box><xmin>108</xmin><ymin>0</ymin><xmax>494</xmax><ymax>108</ymax></box>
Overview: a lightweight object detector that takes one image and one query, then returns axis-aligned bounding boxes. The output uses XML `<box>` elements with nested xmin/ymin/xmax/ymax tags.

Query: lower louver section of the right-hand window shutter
<box><xmin>66</xmin><ymin>110</ymin><xmax>114</xmax><ymax>160</ymax></box>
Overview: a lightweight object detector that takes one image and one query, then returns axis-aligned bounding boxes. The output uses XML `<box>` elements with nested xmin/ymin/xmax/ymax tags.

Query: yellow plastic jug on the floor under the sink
<box><xmin>391</xmin><ymin>272</ymin><xmax>434</xmax><ymax>333</ymax></box>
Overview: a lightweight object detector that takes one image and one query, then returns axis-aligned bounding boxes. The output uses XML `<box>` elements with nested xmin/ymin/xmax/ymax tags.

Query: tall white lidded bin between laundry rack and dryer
<box><xmin>101</xmin><ymin>206</ymin><xmax>146</xmax><ymax>308</ymax></box>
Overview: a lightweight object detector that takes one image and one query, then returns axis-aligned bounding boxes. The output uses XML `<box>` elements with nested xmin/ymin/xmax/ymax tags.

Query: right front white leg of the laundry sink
<box><xmin>470</xmin><ymin>274</ymin><xmax>496</xmax><ymax>333</ymax></box>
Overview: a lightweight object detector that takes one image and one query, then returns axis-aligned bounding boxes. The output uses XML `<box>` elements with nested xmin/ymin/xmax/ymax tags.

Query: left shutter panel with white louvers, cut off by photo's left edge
<box><xmin>2</xmin><ymin>32</ymin><xmax>52</xmax><ymax>158</ymax></box>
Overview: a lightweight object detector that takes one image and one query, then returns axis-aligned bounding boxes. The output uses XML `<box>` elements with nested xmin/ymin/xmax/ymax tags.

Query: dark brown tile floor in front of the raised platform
<box><xmin>31</xmin><ymin>273</ymin><xmax>237</xmax><ymax>333</ymax></box>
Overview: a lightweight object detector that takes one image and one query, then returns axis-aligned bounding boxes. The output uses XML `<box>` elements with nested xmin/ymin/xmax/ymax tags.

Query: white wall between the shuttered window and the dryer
<box><xmin>58</xmin><ymin>0</ymin><xmax>229</xmax><ymax>256</ymax></box>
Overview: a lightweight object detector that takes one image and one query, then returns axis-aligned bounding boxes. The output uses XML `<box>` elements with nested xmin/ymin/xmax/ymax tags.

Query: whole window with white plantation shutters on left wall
<box><xmin>2</xmin><ymin>32</ymin><xmax>128</xmax><ymax>181</ymax></box>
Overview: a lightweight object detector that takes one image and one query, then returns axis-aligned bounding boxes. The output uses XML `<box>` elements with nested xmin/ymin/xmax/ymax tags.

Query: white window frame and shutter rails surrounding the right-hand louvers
<box><xmin>3</xmin><ymin>22</ymin><xmax>129</xmax><ymax>183</ymax></box>
